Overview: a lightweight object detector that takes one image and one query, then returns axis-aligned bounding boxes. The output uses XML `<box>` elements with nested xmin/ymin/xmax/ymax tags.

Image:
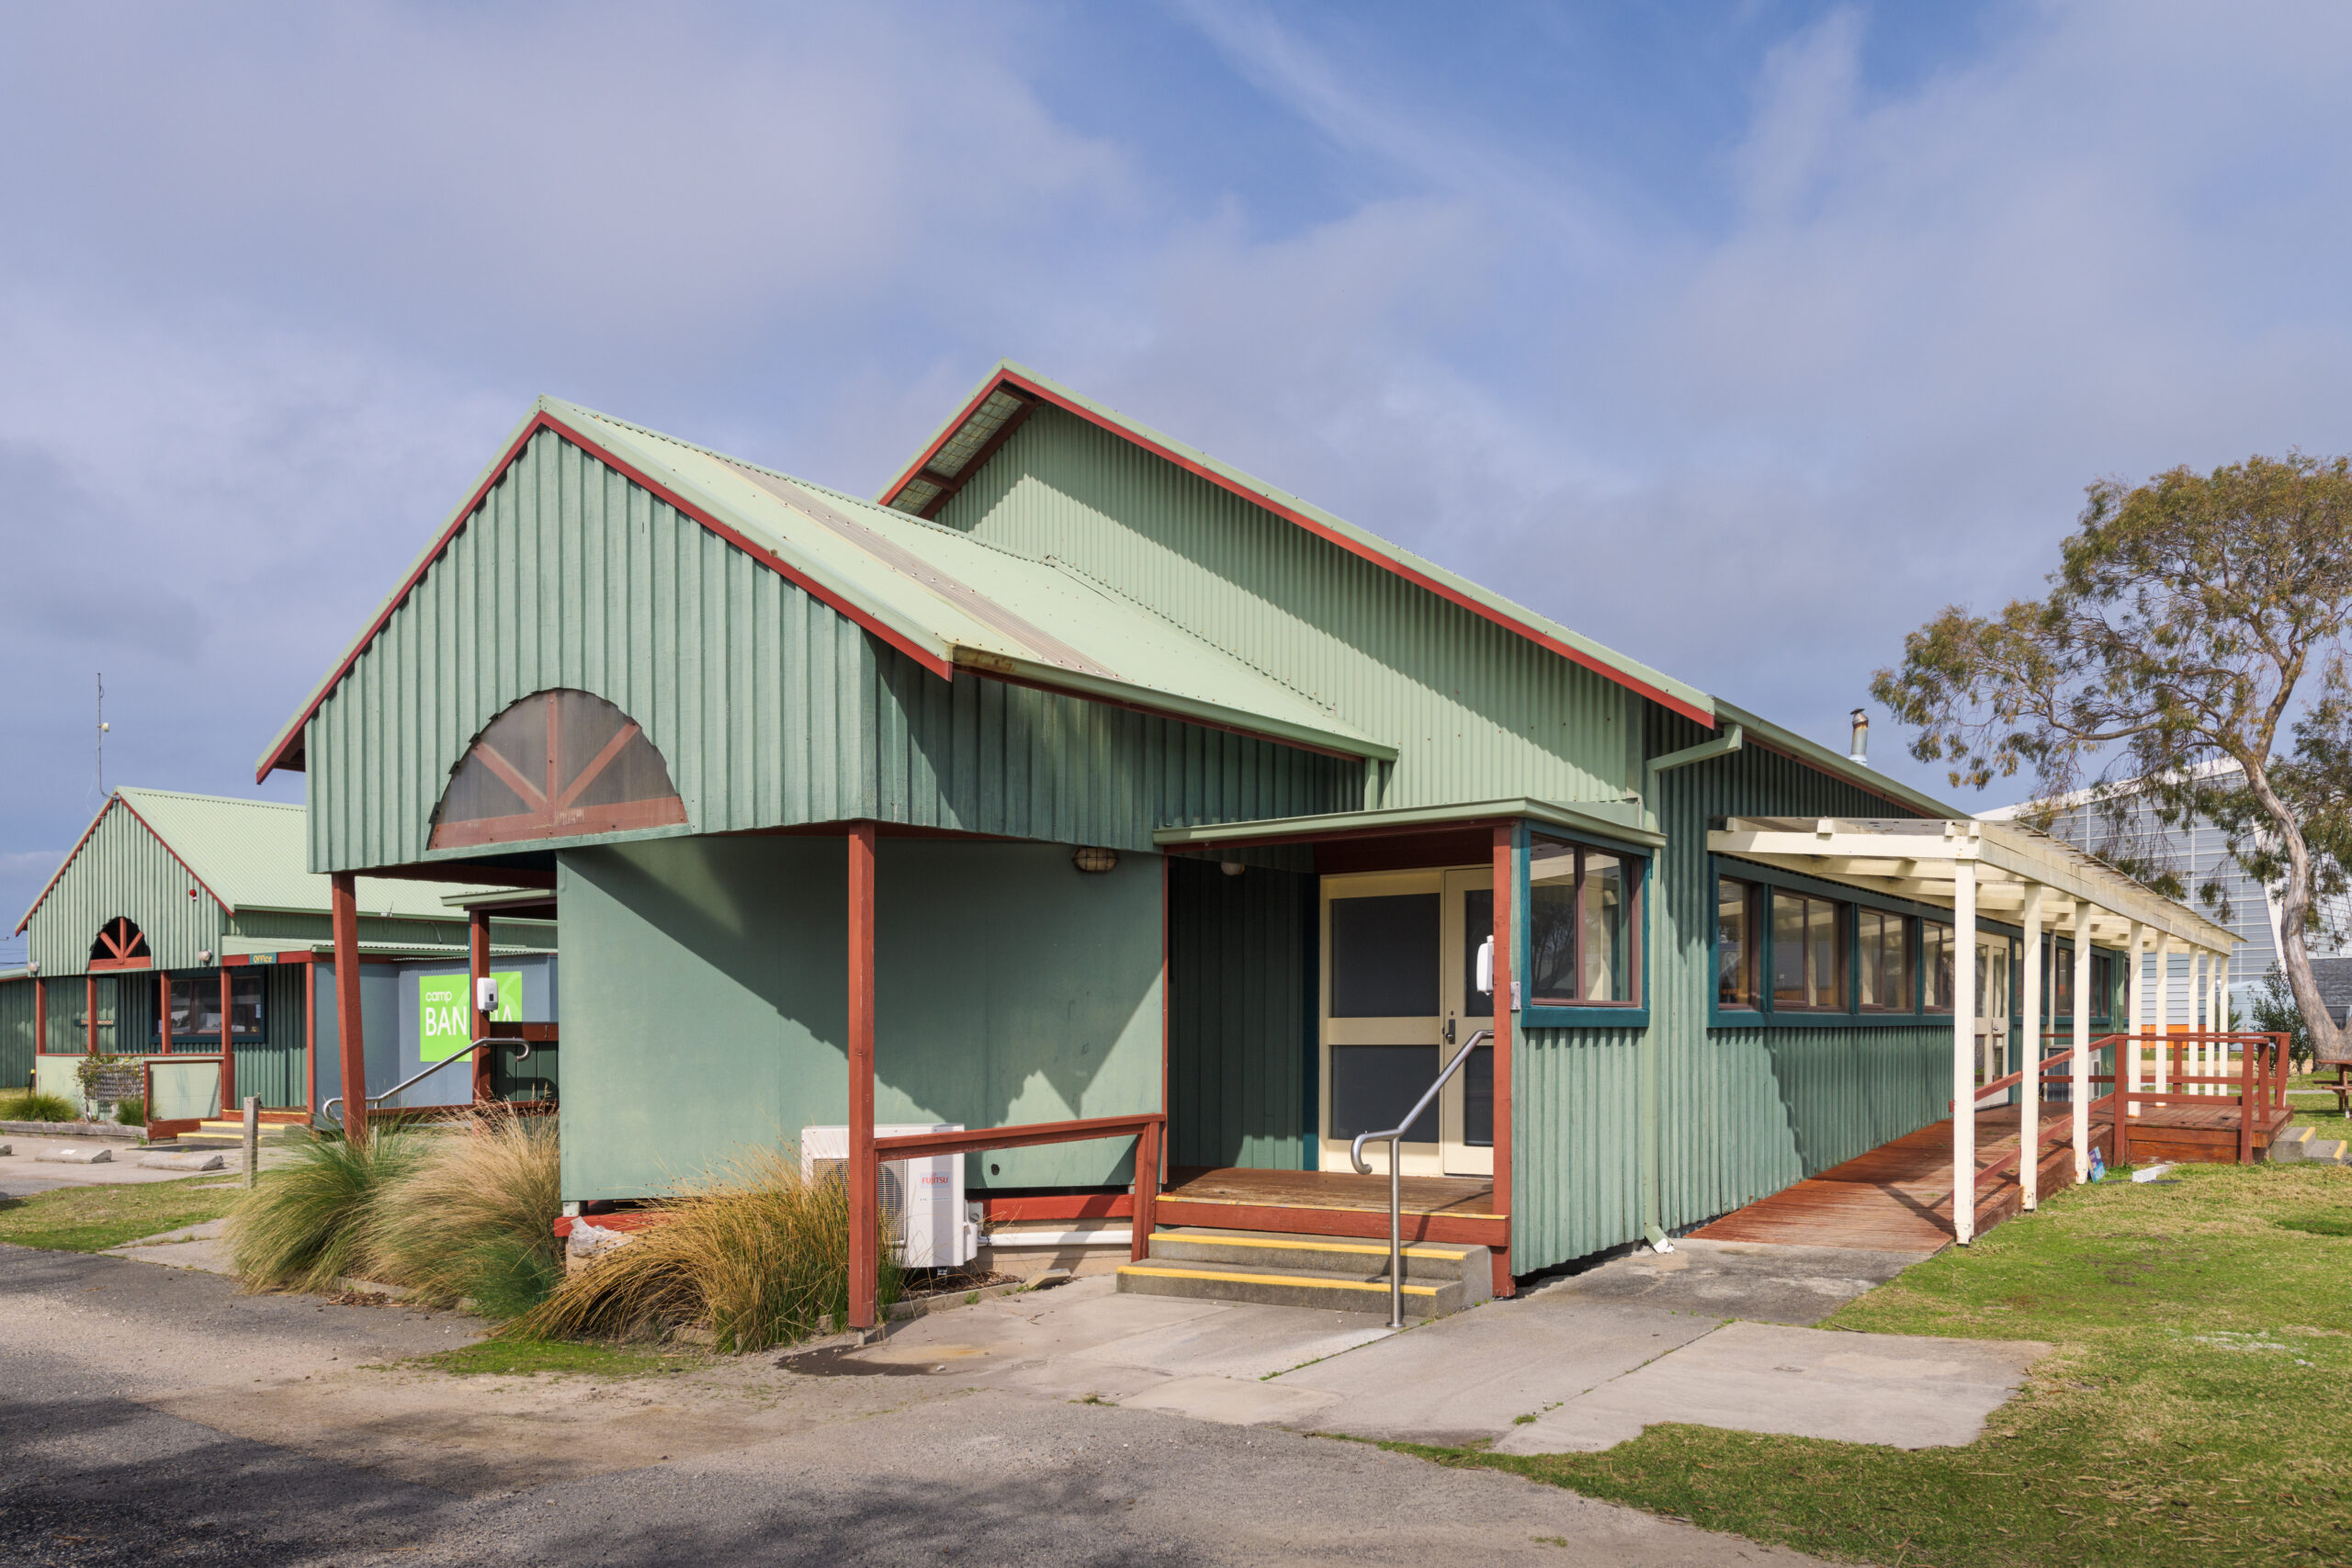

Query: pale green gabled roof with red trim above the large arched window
<box><xmin>259</xmin><ymin>398</ymin><xmax>1397</xmax><ymax>776</ymax></box>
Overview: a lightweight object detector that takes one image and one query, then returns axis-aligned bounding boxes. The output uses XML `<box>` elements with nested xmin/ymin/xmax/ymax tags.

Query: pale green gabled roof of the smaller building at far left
<box><xmin>17</xmin><ymin>790</ymin><xmax>529</xmax><ymax>936</ymax></box>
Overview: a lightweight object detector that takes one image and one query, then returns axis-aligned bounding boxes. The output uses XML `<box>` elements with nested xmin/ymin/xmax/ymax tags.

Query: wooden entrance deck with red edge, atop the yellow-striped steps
<box><xmin>1158</xmin><ymin>1166</ymin><xmax>1510</xmax><ymax>1246</ymax></box>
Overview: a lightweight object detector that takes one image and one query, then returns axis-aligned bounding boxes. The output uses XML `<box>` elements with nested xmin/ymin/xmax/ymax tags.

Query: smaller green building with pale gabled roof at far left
<box><xmin>0</xmin><ymin>790</ymin><xmax>555</xmax><ymax>1123</ymax></box>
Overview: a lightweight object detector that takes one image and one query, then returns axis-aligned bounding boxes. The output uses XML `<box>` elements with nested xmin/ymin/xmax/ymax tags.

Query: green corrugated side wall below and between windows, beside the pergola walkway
<box><xmin>1512</xmin><ymin>710</ymin><xmax>1952</xmax><ymax>1272</ymax></box>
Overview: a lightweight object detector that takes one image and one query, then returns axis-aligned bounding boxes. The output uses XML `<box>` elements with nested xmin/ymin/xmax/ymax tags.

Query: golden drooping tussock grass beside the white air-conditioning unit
<box><xmin>501</xmin><ymin>1149</ymin><xmax>899</xmax><ymax>1352</ymax></box>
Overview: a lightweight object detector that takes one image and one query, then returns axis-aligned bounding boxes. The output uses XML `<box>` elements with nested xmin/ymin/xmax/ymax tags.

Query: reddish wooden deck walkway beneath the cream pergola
<box><xmin>1691</xmin><ymin>1105</ymin><xmax>2108</xmax><ymax>1256</ymax></box>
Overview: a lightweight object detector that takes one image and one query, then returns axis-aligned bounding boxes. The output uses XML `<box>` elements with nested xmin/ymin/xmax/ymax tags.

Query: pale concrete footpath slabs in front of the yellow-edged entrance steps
<box><xmin>855</xmin><ymin>1241</ymin><xmax>2046</xmax><ymax>1453</ymax></box>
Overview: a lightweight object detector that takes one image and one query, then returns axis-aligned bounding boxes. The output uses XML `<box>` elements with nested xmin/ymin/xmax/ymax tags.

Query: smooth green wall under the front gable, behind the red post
<box><xmin>558</xmin><ymin>835</ymin><xmax>1162</xmax><ymax>1199</ymax></box>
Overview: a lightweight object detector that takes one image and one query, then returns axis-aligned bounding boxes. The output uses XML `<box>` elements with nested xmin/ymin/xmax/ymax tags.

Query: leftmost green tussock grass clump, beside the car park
<box><xmin>228</xmin><ymin>1126</ymin><xmax>425</xmax><ymax>1291</ymax></box>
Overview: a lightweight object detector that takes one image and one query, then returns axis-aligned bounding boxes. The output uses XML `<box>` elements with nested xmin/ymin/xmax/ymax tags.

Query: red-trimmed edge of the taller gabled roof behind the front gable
<box><xmin>877</xmin><ymin>360</ymin><xmax>1714</xmax><ymax>728</ymax></box>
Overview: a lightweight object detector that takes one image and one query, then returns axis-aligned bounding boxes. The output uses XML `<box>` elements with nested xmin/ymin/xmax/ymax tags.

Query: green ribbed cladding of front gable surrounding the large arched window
<box><xmin>303</xmin><ymin>430</ymin><xmax>1362</xmax><ymax>870</ymax></box>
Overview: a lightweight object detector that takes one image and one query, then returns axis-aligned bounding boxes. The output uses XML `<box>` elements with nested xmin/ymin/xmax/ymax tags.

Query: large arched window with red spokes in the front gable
<box><xmin>433</xmin><ymin>689</ymin><xmax>687</xmax><ymax>849</ymax></box>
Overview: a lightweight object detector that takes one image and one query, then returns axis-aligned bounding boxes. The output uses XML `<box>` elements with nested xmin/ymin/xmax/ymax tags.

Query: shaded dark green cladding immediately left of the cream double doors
<box><xmin>1169</xmin><ymin>858</ymin><xmax>1315</xmax><ymax>1170</ymax></box>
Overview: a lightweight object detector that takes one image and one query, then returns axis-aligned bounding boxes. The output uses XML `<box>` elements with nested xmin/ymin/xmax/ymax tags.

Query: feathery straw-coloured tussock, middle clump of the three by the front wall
<box><xmin>367</xmin><ymin>1107</ymin><xmax>564</xmax><ymax>1319</ymax></box>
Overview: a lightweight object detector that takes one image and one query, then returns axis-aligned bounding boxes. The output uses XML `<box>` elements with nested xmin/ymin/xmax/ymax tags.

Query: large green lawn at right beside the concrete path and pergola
<box><xmin>1414</xmin><ymin>1166</ymin><xmax>2352</xmax><ymax>1568</ymax></box>
